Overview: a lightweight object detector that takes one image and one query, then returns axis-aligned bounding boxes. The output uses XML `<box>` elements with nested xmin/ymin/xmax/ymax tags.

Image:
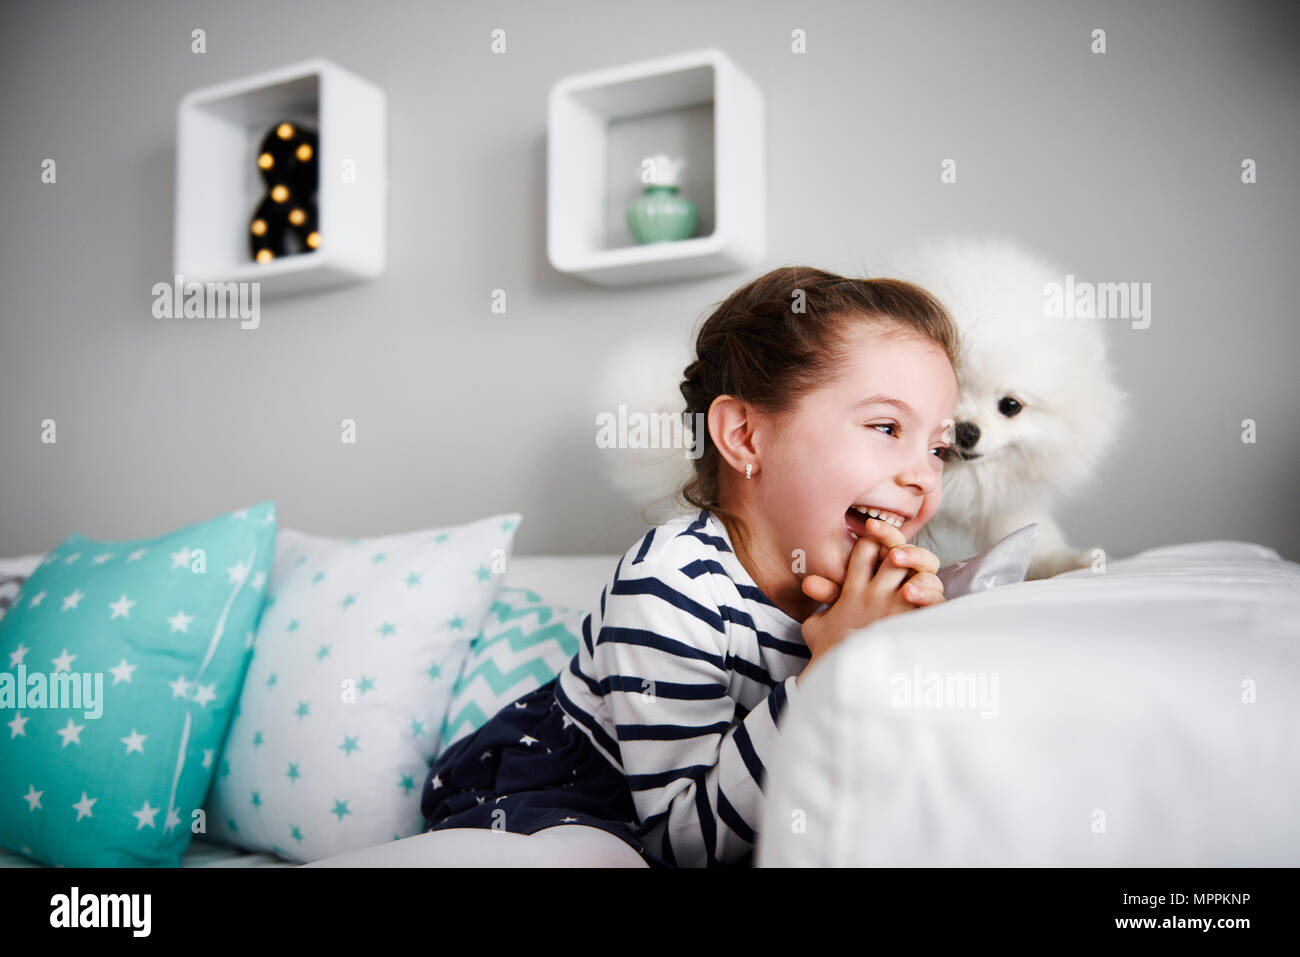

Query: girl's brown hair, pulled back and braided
<box><xmin>676</xmin><ymin>265</ymin><xmax>959</xmax><ymax>556</ymax></box>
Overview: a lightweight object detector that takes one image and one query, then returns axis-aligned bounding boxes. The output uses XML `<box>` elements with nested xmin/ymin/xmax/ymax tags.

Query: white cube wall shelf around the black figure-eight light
<box><xmin>173</xmin><ymin>59</ymin><xmax>387</xmax><ymax>295</ymax></box>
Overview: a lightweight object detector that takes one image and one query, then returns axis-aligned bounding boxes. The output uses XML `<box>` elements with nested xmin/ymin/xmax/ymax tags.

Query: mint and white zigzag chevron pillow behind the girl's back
<box><xmin>439</xmin><ymin>585</ymin><xmax>588</xmax><ymax>754</ymax></box>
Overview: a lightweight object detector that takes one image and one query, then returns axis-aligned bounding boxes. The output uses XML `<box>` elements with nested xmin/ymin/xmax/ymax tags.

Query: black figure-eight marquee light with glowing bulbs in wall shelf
<box><xmin>248</xmin><ymin>121</ymin><xmax>321</xmax><ymax>263</ymax></box>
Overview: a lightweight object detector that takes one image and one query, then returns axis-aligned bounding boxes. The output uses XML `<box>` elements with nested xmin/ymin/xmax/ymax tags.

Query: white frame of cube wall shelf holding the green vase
<box><xmin>546</xmin><ymin>48</ymin><xmax>767</xmax><ymax>285</ymax></box>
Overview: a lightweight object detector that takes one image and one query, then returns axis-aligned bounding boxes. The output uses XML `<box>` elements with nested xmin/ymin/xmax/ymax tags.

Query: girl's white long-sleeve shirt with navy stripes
<box><xmin>555</xmin><ymin>510</ymin><xmax>810</xmax><ymax>867</ymax></box>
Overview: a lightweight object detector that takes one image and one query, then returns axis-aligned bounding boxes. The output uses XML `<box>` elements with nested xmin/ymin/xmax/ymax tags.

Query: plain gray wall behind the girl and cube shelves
<box><xmin>0</xmin><ymin>0</ymin><xmax>1300</xmax><ymax>559</ymax></box>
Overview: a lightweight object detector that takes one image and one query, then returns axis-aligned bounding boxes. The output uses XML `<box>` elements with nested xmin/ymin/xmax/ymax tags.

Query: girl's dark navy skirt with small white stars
<box><xmin>420</xmin><ymin>679</ymin><xmax>664</xmax><ymax>867</ymax></box>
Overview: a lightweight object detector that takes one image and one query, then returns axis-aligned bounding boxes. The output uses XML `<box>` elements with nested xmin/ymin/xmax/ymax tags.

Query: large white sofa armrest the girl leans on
<box><xmin>755</xmin><ymin>541</ymin><xmax>1300</xmax><ymax>867</ymax></box>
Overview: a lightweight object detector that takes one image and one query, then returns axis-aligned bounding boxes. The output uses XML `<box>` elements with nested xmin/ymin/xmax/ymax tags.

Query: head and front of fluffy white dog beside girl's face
<box><xmin>888</xmin><ymin>239</ymin><xmax>1128</xmax><ymax>579</ymax></box>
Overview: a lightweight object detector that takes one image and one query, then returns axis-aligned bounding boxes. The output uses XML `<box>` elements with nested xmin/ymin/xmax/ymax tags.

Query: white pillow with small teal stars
<box><xmin>207</xmin><ymin>512</ymin><xmax>520</xmax><ymax>862</ymax></box>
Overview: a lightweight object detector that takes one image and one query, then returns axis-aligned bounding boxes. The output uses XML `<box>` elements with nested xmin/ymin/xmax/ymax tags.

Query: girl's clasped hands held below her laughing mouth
<box><xmin>796</xmin><ymin>518</ymin><xmax>945</xmax><ymax>681</ymax></box>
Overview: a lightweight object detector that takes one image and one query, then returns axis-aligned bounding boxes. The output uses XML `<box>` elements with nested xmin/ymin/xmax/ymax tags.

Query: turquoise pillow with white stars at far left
<box><xmin>0</xmin><ymin>502</ymin><xmax>276</xmax><ymax>867</ymax></box>
